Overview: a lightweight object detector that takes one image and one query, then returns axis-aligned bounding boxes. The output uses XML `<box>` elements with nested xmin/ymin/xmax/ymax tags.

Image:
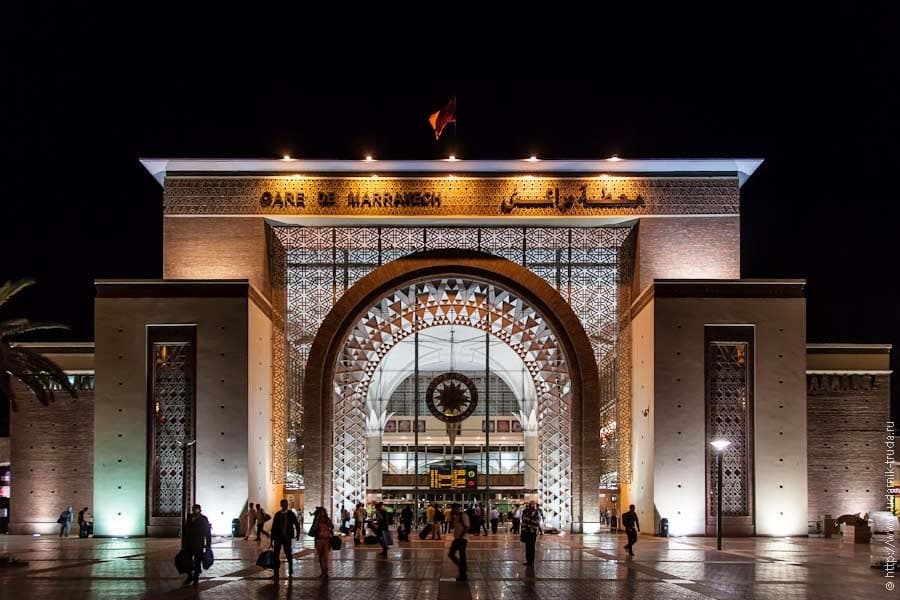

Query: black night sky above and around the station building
<box><xmin>0</xmin><ymin>7</ymin><xmax>900</xmax><ymax>420</ymax></box>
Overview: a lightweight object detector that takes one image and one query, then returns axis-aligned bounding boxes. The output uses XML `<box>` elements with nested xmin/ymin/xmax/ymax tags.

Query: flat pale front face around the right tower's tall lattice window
<box><xmin>645</xmin><ymin>296</ymin><xmax>807</xmax><ymax>535</ymax></box>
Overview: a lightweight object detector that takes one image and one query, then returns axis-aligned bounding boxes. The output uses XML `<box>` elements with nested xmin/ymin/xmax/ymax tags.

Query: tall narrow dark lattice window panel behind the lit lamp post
<box><xmin>706</xmin><ymin>342</ymin><xmax>751</xmax><ymax>517</ymax></box>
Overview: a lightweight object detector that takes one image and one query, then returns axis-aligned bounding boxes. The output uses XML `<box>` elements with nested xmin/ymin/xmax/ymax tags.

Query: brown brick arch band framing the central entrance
<box><xmin>303</xmin><ymin>250</ymin><xmax>600</xmax><ymax>531</ymax></box>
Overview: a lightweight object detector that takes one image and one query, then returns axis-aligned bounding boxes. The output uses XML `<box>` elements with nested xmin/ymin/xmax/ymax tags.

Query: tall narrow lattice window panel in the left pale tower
<box><xmin>149</xmin><ymin>342</ymin><xmax>194</xmax><ymax>517</ymax></box>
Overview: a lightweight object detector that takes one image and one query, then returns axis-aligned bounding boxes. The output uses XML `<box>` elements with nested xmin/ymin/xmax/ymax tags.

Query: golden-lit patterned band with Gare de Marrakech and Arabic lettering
<box><xmin>165</xmin><ymin>176</ymin><xmax>739</xmax><ymax>217</ymax></box>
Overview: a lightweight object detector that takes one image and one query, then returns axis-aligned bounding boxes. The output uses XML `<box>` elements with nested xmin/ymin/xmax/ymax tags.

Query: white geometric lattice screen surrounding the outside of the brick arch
<box><xmin>269</xmin><ymin>226</ymin><xmax>630</xmax><ymax>496</ymax></box>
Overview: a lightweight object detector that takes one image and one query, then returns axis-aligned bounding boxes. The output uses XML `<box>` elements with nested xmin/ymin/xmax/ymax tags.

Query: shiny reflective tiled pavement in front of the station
<box><xmin>0</xmin><ymin>533</ymin><xmax>888</xmax><ymax>600</ymax></box>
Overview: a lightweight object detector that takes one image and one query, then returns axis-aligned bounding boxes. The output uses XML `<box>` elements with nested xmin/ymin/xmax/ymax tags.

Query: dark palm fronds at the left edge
<box><xmin>0</xmin><ymin>279</ymin><xmax>78</xmax><ymax>410</ymax></box>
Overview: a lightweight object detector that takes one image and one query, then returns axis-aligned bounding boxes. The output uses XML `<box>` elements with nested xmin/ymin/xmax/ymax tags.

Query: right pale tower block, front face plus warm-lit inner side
<box><xmin>622</xmin><ymin>280</ymin><xmax>807</xmax><ymax>535</ymax></box>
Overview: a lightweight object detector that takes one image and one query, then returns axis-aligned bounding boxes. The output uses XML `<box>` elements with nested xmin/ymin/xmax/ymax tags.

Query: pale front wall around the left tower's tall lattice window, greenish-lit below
<box><xmin>94</xmin><ymin>290</ymin><xmax>250</xmax><ymax>535</ymax></box>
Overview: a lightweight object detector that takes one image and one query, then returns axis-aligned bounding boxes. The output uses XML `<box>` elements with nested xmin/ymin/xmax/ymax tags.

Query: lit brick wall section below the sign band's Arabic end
<box><xmin>634</xmin><ymin>215</ymin><xmax>741</xmax><ymax>297</ymax></box>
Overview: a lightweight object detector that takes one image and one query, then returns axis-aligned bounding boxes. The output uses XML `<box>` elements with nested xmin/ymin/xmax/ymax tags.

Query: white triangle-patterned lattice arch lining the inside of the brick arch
<box><xmin>333</xmin><ymin>278</ymin><xmax>572</xmax><ymax>527</ymax></box>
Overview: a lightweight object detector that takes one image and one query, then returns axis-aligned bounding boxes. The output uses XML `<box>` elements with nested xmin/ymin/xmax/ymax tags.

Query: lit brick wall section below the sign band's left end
<box><xmin>163</xmin><ymin>216</ymin><xmax>270</xmax><ymax>297</ymax></box>
